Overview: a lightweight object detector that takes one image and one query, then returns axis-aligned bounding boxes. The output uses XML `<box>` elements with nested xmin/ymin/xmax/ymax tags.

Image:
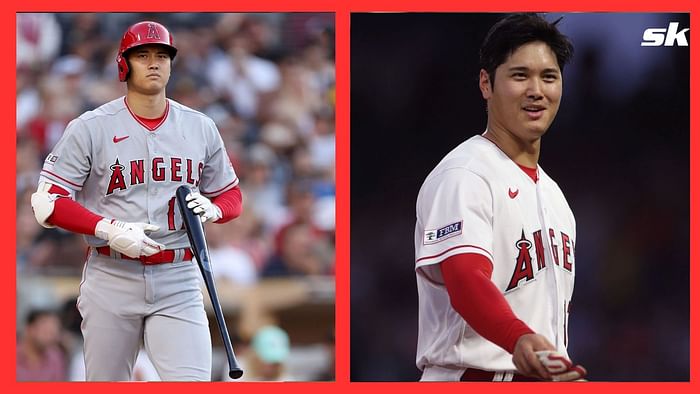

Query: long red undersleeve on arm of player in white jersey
<box><xmin>440</xmin><ymin>253</ymin><xmax>533</xmax><ymax>354</ymax></box>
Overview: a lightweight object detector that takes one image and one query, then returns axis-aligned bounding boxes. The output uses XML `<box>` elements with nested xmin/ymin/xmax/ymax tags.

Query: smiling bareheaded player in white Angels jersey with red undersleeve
<box><xmin>415</xmin><ymin>14</ymin><xmax>586</xmax><ymax>381</ymax></box>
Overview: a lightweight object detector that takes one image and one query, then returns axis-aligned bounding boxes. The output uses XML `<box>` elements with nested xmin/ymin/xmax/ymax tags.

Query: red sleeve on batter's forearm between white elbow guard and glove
<box><xmin>46</xmin><ymin>185</ymin><xmax>102</xmax><ymax>235</ymax></box>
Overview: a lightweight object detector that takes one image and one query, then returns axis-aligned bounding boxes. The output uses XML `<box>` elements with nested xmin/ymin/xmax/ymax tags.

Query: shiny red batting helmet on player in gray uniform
<box><xmin>117</xmin><ymin>21</ymin><xmax>177</xmax><ymax>82</ymax></box>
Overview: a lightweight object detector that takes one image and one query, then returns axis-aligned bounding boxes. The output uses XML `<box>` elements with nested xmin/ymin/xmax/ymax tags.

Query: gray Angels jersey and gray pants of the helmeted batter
<box><xmin>40</xmin><ymin>97</ymin><xmax>238</xmax><ymax>381</ymax></box>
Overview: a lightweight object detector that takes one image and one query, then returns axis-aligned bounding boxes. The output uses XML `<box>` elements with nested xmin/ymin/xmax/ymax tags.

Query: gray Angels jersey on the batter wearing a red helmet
<box><xmin>41</xmin><ymin>97</ymin><xmax>238</xmax><ymax>249</ymax></box>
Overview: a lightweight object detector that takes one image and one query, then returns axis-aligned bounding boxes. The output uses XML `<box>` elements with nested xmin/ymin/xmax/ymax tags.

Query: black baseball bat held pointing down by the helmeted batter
<box><xmin>175</xmin><ymin>185</ymin><xmax>243</xmax><ymax>379</ymax></box>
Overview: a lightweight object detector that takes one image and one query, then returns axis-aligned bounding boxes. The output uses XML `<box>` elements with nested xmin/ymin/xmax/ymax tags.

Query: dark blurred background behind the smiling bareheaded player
<box><xmin>351</xmin><ymin>13</ymin><xmax>690</xmax><ymax>381</ymax></box>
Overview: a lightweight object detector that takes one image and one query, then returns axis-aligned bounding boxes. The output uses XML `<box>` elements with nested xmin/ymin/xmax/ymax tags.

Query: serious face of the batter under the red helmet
<box><xmin>129</xmin><ymin>45</ymin><xmax>170</xmax><ymax>94</ymax></box>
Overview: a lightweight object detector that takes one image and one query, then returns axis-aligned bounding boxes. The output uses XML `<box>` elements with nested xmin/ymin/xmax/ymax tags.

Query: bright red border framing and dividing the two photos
<box><xmin>0</xmin><ymin>0</ymin><xmax>700</xmax><ymax>394</ymax></box>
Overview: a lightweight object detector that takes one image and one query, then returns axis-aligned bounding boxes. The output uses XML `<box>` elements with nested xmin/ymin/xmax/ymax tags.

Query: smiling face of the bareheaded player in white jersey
<box><xmin>479</xmin><ymin>41</ymin><xmax>562</xmax><ymax>143</ymax></box>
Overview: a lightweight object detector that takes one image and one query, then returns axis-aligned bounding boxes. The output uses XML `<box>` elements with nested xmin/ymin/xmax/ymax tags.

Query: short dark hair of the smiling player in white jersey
<box><xmin>479</xmin><ymin>13</ymin><xmax>574</xmax><ymax>86</ymax></box>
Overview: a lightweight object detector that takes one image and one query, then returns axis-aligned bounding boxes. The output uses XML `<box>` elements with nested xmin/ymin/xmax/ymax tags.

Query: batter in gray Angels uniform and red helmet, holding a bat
<box><xmin>31</xmin><ymin>21</ymin><xmax>242</xmax><ymax>381</ymax></box>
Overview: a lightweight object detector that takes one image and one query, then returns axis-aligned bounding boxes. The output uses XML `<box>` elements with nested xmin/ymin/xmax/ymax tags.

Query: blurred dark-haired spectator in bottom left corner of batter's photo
<box><xmin>17</xmin><ymin>310</ymin><xmax>66</xmax><ymax>381</ymax></box>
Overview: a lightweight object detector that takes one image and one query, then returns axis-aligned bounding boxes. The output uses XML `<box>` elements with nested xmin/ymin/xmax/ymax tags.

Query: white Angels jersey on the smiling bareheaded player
<box><xmin>415</xmin><ymin>135</ymin><xmax>576</xmax><ymax>380</ymax></box>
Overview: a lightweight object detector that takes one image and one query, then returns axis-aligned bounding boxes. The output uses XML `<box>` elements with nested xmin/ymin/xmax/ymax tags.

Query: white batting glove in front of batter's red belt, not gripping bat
<box><xmin>95</xmin><ymin>219</ymin><xmax>165</xmax><ymax>258</ymax></box>
